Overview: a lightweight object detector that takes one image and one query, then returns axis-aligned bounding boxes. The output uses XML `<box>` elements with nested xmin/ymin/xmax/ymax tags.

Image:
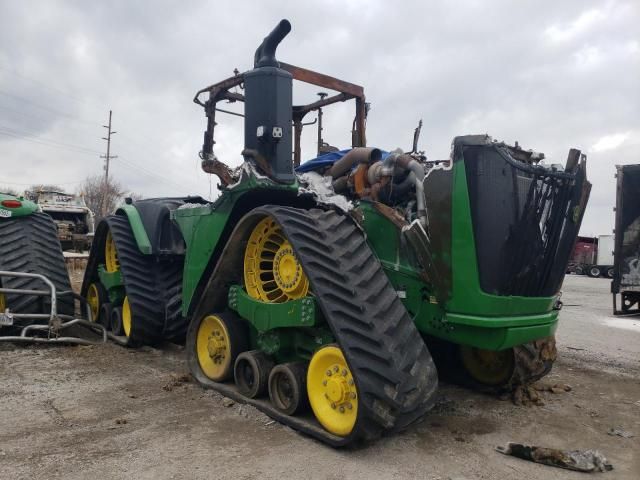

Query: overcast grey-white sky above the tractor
<box><xmin>0</xmin><ymin>0</ymin><xmax>640</xmax><ymax>235</ymax></box>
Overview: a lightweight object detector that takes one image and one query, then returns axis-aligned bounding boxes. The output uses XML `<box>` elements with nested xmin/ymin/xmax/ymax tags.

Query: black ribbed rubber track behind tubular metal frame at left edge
<box><xmin>0</xmin><ymin>213</ymin><xmax>74</xmax><ymax>315</ymax></box>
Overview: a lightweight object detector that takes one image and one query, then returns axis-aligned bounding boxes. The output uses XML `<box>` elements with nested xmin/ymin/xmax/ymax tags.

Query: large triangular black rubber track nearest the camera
<box><xmin>187</xmin><ymin>205</ymin><xmax>438</xmax><ymax>446</ymax></box>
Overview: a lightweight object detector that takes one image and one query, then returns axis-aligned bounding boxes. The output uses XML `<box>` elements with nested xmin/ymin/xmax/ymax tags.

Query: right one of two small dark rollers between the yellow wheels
<box><xmin>269</xmin><ymin>363</ymin><xmax>309</xmax><ymax>415</ymax></box>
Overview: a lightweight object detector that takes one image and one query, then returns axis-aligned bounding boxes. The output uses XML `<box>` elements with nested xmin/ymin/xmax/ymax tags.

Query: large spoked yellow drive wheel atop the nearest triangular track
<box><xmin>244</xmin><ymin>217</ymin><xmax>309</xmax><ymax>303</ymax></box>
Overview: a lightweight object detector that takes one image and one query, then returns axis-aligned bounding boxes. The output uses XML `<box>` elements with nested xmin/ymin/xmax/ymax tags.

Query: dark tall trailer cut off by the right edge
<box><xmin>611</xmin><ymin>165</ymin><xmax>640</xmax><ymax>315</ymax></box>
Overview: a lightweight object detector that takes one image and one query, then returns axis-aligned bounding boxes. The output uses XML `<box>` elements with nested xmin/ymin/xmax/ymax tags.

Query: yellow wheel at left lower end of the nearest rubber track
<box><xmin>196</xmin><ymin>315</ymin><xmax>232</xmax><ymax>382</ymax></box>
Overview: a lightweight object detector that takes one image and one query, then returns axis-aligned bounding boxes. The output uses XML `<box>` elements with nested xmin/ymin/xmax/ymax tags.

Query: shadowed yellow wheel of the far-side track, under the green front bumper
<box><xmin>460</xmin><ymin>346</ymin><xmax>515</xmax><ymax>385</ymax></box>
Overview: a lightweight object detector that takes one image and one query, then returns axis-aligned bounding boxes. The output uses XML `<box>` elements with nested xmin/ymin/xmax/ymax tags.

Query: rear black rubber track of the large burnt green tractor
<box><xmin>82</xmin><ymin>215</ymin><xmax>187</xmax><ymax>346</ymax></box>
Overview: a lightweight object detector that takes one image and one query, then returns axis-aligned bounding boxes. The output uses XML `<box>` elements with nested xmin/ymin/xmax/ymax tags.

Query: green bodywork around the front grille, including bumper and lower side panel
<box><xmin>359</xmin><ymin>162</ymin><xmax>558</xmax><ymax>350</ymax></box>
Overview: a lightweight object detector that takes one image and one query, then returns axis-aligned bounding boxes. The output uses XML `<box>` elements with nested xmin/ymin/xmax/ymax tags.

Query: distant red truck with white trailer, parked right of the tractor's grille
<box><xmin>567</xmin><ymin>235</ymin><xmax>614</xmax><ymax>278</ymax></box>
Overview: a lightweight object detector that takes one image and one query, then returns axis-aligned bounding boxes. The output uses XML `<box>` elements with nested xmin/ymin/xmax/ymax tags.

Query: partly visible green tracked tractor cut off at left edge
<box><xmin>0</xmin><ymin>193</ymin><xmax>74</xmax><ymax>334</ymax></box>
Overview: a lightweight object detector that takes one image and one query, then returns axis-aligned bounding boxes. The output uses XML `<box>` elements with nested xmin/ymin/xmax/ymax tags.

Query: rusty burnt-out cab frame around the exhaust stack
<box><xmin>193</xmin><ymin>62</ymin><xmax>367</xmax><ymax>167</ymax></box>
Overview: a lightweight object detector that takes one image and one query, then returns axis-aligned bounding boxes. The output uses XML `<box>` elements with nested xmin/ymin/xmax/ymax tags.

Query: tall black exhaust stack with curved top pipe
<box><xmin>243</xmin><ymin>20</ymin><xmax>295</xmax><ymax>183</ymax></box>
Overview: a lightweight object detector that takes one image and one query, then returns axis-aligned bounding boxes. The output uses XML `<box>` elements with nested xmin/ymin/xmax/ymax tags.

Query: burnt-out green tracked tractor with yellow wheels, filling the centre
<box><xmin>83</xmin><ymin>20</ymin><xmax>589</xmax><ymax>446</ymax></box>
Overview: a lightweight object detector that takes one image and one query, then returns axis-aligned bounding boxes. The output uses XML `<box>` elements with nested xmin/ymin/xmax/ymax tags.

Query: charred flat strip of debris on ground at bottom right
<box><xmin>496</xmin><ymin>442</ymin><xmax>613</xmax><ymax>473</ymax></box>
